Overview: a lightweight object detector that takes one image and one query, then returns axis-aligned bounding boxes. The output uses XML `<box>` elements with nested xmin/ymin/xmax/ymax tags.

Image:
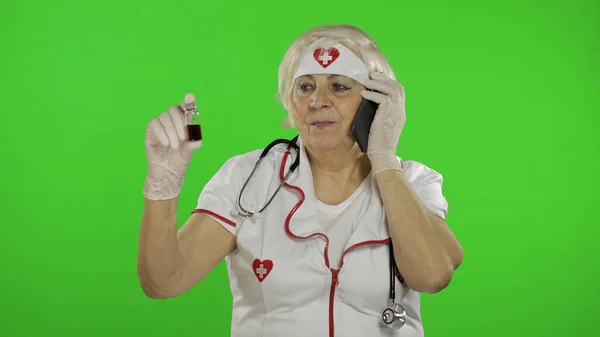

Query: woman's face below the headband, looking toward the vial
<box><xmin>292</xmin><ymin>74</ymin><xmax>365</xmax><ymax>152</ymax></box>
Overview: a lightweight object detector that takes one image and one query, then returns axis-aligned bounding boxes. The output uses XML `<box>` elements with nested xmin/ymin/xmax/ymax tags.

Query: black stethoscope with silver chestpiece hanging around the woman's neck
<box><xmin>237</xmin><ymin>136</ymin><xmax>406</xmax><ymax>330</ymax></box>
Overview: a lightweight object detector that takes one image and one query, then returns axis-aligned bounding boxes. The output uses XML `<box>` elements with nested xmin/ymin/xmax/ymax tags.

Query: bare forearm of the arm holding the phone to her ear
<box><xmin>376</xmin><ymin>170</ymin><xmax>462</xmax><ymax>293</ymax></box>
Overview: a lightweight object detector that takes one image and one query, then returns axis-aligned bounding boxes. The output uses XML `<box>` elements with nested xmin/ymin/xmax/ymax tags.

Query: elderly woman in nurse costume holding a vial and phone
<box><xmin>138</xmin><ymin>25</ymin><xmax>463</xmax><ymax>337</ymax></box>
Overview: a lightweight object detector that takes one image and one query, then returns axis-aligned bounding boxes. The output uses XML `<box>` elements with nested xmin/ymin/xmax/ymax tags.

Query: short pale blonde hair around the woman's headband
<box><xmin>276</xmin><ymin>24</ymin><xmax>396</xmax><ymax>128</ymax></box>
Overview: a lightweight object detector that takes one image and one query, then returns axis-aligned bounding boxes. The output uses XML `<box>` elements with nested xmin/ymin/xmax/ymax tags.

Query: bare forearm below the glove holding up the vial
<box><xmin>138</xmin><ymin>198</ymin><xmax>183</xmax><ymax>298</ymax></box>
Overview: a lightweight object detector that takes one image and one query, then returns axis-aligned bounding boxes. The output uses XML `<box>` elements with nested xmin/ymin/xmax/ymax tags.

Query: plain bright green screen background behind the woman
<box><xmin>0</xmin><ymin>0</ymin><xmax>600</xmax><ymax>337</ymax></box>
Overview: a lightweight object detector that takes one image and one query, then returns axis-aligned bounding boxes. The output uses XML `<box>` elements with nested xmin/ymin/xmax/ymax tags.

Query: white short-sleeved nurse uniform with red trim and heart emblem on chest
<box><xmin>194</xmin><ymin>137</ymin><xmax>447</xmax><ymax>337</ymax></box>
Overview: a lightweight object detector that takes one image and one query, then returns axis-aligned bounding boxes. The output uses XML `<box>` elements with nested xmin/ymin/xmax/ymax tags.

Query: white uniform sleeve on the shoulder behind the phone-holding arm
<box><xmin>403</xmin><ymin>161</ymin><xmax>448</xmax><ymax>220</ymax></box>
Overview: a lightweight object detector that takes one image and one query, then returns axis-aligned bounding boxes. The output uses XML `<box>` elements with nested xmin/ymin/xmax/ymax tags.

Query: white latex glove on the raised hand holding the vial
<box><xmin>143</xmin><ymin>94</ymin><xmax>202</xmax><ymax>200</ymax></box>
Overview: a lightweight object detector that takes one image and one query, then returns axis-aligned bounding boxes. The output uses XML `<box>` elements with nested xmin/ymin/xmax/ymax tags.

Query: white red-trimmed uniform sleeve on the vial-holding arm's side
<box><xmin>192</xmin><ymin>157</ymin><xmax>242</xmax><ymax>236</ymax></box>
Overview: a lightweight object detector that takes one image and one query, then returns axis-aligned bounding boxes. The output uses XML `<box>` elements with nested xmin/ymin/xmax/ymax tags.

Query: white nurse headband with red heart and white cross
<box><xmin>292</xmin><ymin>43</ymin><xmax>369</xmax><ymax>84</ymax></box>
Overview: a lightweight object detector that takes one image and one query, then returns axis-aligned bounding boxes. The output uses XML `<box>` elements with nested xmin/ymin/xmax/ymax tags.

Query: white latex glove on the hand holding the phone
<box><xmin>361</xmin><ymin>73</ymin><xmax>406</xmax><ymax>174</ymax></box>
